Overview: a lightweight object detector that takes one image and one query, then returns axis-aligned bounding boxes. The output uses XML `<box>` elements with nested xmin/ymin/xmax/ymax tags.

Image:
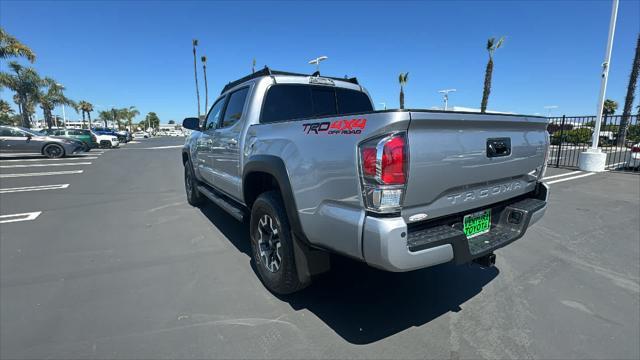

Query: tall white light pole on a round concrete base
<box><xmin>579</xmin><ymin>0</ymin><xmax>619</xmax><ymax>172</ymax></box>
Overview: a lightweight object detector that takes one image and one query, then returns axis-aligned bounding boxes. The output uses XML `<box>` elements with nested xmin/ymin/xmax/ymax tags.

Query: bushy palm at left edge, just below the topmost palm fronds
<box><xmin>0</xmin><ymin>61</ymin><xmax>42</xmax><ymax>128</ymax></box>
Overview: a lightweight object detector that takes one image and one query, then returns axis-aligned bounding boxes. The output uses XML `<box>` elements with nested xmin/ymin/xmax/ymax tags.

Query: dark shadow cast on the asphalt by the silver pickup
<box><xmin>200</xmin><ymin>204</ymin><xmax>499</xmax><ymax>344</ymax></box>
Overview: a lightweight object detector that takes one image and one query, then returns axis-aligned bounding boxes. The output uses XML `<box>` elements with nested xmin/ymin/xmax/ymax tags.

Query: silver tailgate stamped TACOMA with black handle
<box><xmin>402</xmin><ymin>112</ymin><xmax>548</xmax><ymax>222</ymax></box>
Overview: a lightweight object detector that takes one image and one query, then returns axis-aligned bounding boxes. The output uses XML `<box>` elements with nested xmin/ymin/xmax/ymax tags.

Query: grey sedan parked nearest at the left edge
<box><xmin>0</xmin><ymin>126</ymin><xmax>84</xmax><ymax>158</ymax></box>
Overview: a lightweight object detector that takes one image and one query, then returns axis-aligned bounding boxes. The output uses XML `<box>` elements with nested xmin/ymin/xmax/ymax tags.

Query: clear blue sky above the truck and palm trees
<box><xmin>0</xmin><ymin>0</ymin><xmax>640</xmax><ymax>122</ymax></box>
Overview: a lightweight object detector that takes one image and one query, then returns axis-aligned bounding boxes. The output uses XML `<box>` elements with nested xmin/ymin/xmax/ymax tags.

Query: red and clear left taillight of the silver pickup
<box><xmin>359</xmin><ymin>133</ymin><xmax>408</xmax><ymax>213</ymax></box>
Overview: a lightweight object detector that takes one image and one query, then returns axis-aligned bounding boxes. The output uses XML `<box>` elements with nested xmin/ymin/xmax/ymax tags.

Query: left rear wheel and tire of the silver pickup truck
<box><xmin>249</xmin><ymin>191</ymin><xmax>309</xmax><ymax>294</ymax></box>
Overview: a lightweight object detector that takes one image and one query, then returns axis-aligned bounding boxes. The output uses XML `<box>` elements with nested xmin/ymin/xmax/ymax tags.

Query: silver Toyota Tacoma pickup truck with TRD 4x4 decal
<box><xmin>182</xmin><ymin>68</ymin><xmax>549</xmax><ymax>294</ymax></box>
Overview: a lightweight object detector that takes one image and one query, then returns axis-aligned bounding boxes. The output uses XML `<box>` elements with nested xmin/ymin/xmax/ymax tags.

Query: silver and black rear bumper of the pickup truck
<box><xmin>362</xmin><ymin>183</ymin><xmax>548</xmax><ymax>272</ymax></box>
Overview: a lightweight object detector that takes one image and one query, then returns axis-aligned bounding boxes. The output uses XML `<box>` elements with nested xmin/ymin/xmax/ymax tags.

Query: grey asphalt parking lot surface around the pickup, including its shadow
<box><xmin>0</xmin><ymin>138</ymin><xmax>640</xmax><ymax>359</ymax></box>
